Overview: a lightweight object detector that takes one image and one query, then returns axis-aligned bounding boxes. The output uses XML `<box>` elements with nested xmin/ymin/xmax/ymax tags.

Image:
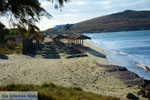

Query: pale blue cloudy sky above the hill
<box><xmin>5</xmin><ymin>0</ymin><xmax>150</xmax><ymax>30</ymax></box>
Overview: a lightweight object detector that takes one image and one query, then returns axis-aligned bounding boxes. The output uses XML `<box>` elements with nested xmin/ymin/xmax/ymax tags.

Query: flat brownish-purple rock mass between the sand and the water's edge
<box><xmin>94</xmin><ymin>62</ymin><xmax>143</xmax><ymax>87</ymax></box>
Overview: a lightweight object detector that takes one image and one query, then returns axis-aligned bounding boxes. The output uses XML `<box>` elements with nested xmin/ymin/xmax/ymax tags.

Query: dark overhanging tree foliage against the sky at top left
<box><xmin>0</xmin><ymin>0</ymin><xmax>68</xmax><ymax>31</ymax></box>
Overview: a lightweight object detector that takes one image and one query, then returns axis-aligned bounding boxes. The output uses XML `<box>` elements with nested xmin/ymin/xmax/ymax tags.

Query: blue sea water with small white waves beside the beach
<box><xmin>86</xmin><ymin>30</ymin><xmax>150</xmax><ymax>80</ymax></box>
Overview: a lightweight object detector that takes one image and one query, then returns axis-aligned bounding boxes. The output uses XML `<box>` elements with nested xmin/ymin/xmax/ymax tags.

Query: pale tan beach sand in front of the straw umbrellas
<box><xmin>0</xmin><ymin>39</ymin><xmax>146</xmax><ymax>99</ymax></box>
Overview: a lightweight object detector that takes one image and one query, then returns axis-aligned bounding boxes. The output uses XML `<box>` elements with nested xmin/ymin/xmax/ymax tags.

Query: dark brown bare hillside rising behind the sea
<box><xmin>46</xmin><ymin>10</ymin><xmax>150</xmax><ymax>33</ymax></box>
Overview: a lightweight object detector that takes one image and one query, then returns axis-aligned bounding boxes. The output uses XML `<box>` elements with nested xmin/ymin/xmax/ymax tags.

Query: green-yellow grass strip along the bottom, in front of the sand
<box><xmin>0</xmin><ymin>83</ymin><xmax>120</xmax><ymax>100</ymax></box>
